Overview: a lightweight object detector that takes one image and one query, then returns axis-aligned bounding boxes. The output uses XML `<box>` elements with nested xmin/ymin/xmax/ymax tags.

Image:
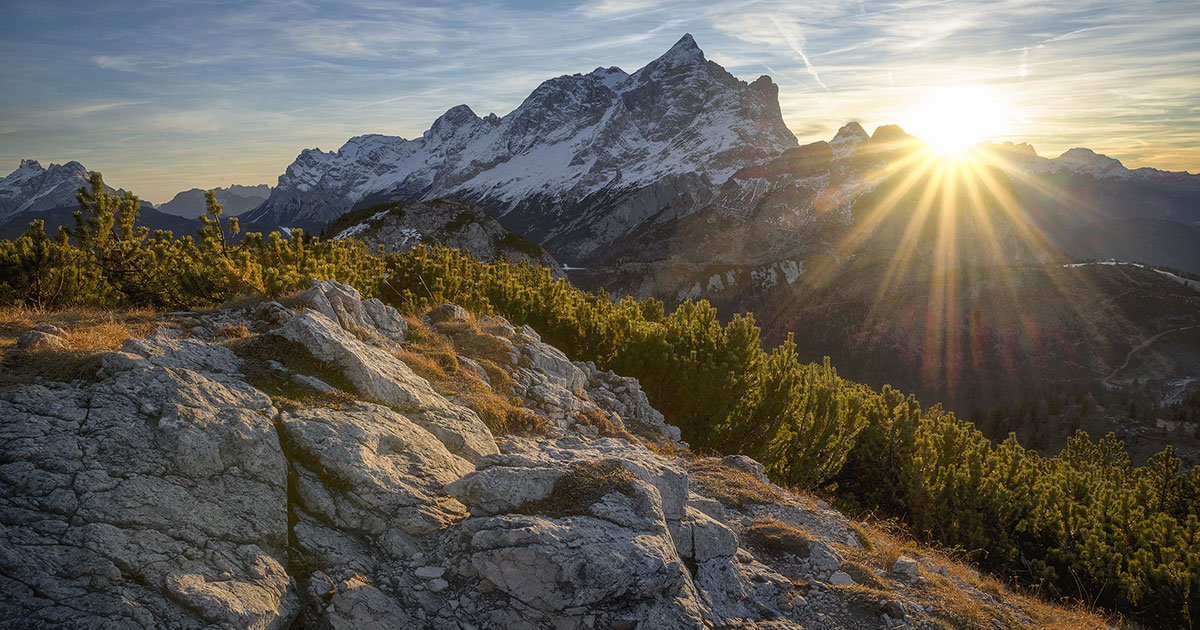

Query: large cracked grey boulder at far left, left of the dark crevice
<box><xmin>0</xmin><ymin>341</ymin><xmax>298</xmax><ymax>629</ymax></box>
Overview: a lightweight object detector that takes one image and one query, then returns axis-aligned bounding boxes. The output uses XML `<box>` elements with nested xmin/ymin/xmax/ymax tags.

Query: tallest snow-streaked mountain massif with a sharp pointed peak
<box><xmin>246</xmin><ymin>35</ymin><xmax>797</xmax><ymax>262</ymax></box>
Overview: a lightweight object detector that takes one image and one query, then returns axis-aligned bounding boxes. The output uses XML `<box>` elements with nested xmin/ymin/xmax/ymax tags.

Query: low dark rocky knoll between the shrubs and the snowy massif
<box><xmin>326</xmin><ymin>199</ymin><xmax>563</xmax><ymax>276</ymax></box>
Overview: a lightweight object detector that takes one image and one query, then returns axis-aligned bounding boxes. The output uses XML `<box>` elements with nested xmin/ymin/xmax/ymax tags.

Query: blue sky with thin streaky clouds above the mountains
<box><xmin>0</xmin><ymin>0</ymin><xmax>1200</xmax><ymax>203</ymax></box>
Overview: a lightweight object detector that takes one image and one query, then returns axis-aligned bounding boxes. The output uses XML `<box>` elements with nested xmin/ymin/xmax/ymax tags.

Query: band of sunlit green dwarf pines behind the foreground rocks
<box><xmin>0</xmin><ymin>174</ymin><xmax>1200</xmax><ymax>628</ymax></box>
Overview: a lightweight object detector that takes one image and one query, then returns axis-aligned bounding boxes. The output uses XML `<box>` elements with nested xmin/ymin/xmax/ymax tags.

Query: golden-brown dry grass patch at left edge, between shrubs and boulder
<box><xmin>0</xmin><ymin>308</ymin><xmax>160</xmax><ymax>389</ymax></box>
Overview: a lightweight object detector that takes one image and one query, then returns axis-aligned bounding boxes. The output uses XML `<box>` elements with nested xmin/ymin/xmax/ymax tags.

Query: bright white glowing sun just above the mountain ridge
<box><xmin>901</xmin><ymin>85</ymin><xmax>1006</xmax><ymax>157</ymax></box>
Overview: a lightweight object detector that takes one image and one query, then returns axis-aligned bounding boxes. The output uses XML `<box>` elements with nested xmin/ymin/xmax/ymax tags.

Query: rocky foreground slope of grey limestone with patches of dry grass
<box><xmin>0</xmin><ymin>281</ymin><xmax>1108</xmax><ymax>629</ymax></box>
